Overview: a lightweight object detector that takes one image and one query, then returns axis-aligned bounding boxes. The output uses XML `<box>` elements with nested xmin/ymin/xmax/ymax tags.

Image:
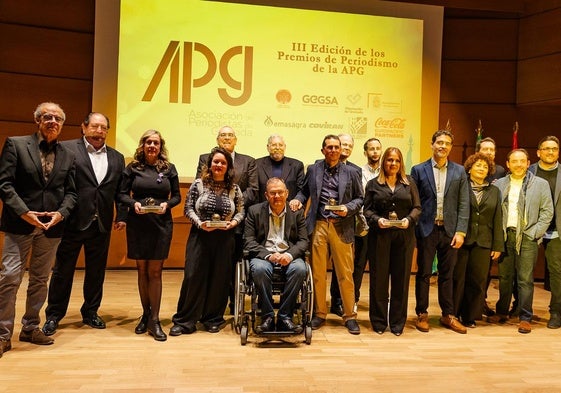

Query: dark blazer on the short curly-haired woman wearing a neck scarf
<box><xmin>464</xmin><ymin>182</ymin><xmax>504</xmax><ymax>252</ymax></box>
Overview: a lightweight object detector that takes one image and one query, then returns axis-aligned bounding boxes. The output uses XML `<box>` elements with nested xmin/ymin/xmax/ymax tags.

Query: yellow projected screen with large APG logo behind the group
<box><xmin>115</xmin><ymin>0</ymin><xmax>423</xmax><ymax>180</ymax></box>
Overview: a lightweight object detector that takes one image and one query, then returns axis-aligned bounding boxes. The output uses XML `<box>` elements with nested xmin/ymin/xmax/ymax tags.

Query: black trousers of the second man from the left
<box><xmin>45</xmin><ymin>222</ymin><xmax>111</xmax><ymax>321</ymax></box>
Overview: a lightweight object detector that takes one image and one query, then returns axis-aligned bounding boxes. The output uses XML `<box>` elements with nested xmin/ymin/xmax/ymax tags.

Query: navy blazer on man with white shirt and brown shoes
<box><xmin>411</xmin><ymin>159</ymin><xmax>469</xmax><ymax>237</ymax></box>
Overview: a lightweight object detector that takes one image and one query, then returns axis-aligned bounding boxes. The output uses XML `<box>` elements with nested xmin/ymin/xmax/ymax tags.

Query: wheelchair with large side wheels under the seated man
<box><xmin>234</xmin><ymin>253</ymin><xmax>314</xmax><ymax>345</ymax></box>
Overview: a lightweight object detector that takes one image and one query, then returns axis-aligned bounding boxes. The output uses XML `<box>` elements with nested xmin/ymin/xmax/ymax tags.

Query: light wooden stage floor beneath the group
<box><xmin>0</xmin><ymin>270</ymin><xmax>561</xmax><ymax>393</ymax></box>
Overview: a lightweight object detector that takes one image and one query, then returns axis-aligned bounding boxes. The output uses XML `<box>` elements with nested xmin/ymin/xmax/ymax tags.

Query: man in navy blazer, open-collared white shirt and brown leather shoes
<box><xmin>411</xmin><ymin>130</ymin><xmax>469</xmax><ymax>334</ymax></box>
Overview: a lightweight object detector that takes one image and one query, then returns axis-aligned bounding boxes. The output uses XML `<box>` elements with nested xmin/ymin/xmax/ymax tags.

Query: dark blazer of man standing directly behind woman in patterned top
<box><xmin>195</xmin><ymin>152</ymin><xmax>259</xmax><ymax>209</ymax></box>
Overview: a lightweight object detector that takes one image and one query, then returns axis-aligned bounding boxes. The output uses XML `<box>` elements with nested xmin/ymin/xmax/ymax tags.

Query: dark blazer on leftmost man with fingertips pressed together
<box><xmin>0</xmin><ymin>133</ymin><xmax>77</xmax><ymax>237</ymax></box>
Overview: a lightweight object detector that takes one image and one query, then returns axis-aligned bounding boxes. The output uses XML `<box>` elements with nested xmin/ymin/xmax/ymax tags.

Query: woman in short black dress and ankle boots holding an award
<box><xmin>119</xmin><ymin>130</ymin><xmax>181</xmax><ymax>341</ymax></box>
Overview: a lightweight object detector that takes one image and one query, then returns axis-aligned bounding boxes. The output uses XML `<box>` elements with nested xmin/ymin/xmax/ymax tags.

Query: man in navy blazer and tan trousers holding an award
<box><xmin>290</xmin><ymin>135</ymin><xmax>364</xmax><ymax>334</ymax></box>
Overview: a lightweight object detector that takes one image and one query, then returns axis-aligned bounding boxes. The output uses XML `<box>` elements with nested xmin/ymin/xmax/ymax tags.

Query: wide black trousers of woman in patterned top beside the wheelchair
<box><xmin>172</xmin><ymin>226</ymin><xmax>234</xmax><ymax>325</ymax></box>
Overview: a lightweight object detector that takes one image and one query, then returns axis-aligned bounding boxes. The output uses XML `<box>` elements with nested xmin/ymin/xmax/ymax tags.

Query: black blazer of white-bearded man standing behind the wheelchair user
<box><xmin>255</xmin><ymin>156</ymin><xmax>304</xmax><ymax>202</ymax></box>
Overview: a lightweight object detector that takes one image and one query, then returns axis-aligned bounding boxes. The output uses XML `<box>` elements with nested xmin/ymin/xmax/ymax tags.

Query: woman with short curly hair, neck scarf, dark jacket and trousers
<box><xmin>454</xmin><ymin>153</ymin><xmax>504</xmax><ymax>328</ymax></box>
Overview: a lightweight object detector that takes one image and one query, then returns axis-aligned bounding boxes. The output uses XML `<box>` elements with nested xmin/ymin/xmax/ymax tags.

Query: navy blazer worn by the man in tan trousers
<box><xmin>295</xmin><ymin>160</ymin><xmax>364</xmax><ymax>243</ymax></box>
